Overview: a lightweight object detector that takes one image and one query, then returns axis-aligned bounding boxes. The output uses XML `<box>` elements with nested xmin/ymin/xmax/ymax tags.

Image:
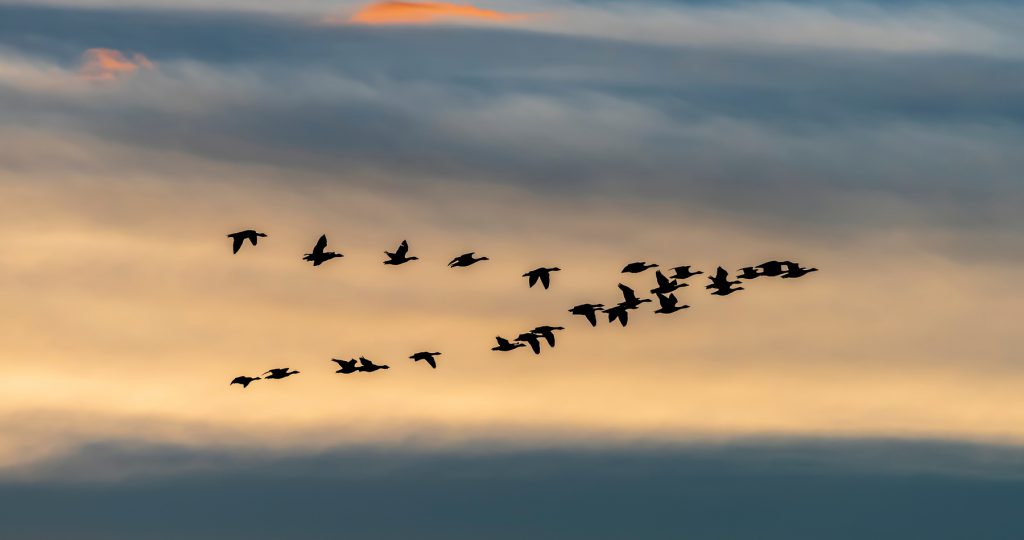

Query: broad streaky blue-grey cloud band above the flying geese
<box><xmin>0</xmin><ymin>6</ymin><xmax>1024</xmax><ymax>242</ymax></box>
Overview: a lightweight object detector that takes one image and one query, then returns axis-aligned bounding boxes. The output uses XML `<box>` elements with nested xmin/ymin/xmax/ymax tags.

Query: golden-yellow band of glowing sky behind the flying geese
<box><xmin>0</xmin><ymin>129</ymin><xmax>1024</xmax><ymax>471</ymax></box>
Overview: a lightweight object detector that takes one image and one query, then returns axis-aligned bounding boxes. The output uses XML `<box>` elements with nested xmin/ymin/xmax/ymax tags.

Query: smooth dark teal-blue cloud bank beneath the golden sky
<box><xmin>0</xmin><ymin>441</ymin><xmax>1024</xmax><ymax>540</ymax></box>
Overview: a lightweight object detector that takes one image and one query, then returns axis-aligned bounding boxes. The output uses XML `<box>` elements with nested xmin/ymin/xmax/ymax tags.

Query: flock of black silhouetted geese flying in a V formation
<box><xmin>227</xmin><ymin>230</ymin><xmax>817</xmax><ymax>388</ymax></box>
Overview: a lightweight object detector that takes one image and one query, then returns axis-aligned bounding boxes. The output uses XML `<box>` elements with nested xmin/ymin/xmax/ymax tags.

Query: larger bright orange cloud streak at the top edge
<box><xmin>344</xmin><ymin>1</ymin><xmax>527</xmax><ymax>25</ymax></box>
